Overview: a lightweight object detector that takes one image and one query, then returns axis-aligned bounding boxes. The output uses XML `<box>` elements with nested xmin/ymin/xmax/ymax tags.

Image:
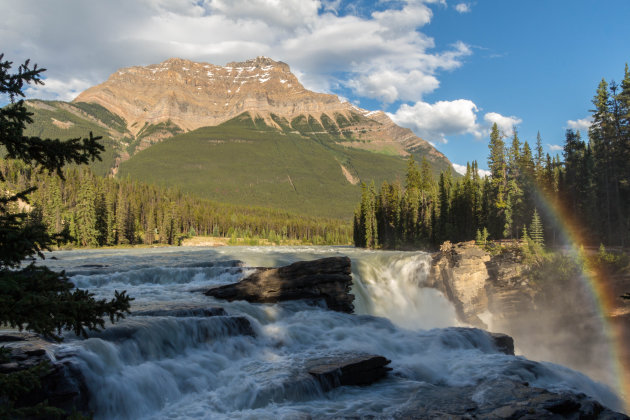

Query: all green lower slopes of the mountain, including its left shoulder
<box><xmin>19</xmin><ymin>100</ymin><xmax>450</xmax><ymax>219</ymax></box>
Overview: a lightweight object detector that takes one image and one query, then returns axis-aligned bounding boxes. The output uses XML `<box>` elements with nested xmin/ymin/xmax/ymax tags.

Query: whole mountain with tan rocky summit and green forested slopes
<box><xmin>21</xmin><ymin>57</ymin><xmax>451</xmax><ymax>217</ymax></box>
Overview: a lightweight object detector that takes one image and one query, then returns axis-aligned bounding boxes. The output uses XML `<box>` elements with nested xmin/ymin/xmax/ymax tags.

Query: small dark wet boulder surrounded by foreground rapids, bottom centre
<box><xmin>307</xmin><ymin>354</ymin><xmax>392</xmax><ymax>391</ymax></box>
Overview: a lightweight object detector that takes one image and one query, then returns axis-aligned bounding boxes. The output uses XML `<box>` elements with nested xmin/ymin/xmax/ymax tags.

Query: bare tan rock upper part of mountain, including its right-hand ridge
<box><xmin>74</xmin><ymin>57</ymin><xmax>447</xmax><ymax>161</ymax></box>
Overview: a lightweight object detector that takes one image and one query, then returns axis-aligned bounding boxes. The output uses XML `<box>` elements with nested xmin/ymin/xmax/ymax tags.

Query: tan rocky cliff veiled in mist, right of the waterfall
<box><xmin>428</xmin><ymin>242</ymin><xmax>630</xmax><ymax>392</ymax></box>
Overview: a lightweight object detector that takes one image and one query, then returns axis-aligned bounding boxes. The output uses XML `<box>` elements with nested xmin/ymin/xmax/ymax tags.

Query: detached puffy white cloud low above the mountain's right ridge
<box><xmin>389</xmin><ymin>99</ymin><xmax>478</xmax><ymax>143</ymax></box>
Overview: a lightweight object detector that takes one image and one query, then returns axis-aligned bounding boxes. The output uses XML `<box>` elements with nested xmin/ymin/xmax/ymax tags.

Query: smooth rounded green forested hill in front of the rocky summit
<box><xmin>119</xmin><ymin>113</ymin><xmax>406</xmax><ymax>217</ymax></box>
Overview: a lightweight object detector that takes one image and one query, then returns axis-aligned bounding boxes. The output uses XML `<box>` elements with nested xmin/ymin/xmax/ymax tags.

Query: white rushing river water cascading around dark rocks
<box><xmin>38</xmin><ymin>247</ymin><xmax>621</xmax><ymax>419</ymax></box>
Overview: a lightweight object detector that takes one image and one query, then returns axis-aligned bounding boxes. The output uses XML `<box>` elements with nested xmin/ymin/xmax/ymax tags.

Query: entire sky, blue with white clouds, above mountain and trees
<box><xmin>0</xmin><ymin>0</ymin><xmax>630</xmax><ymax>173</ymax></box>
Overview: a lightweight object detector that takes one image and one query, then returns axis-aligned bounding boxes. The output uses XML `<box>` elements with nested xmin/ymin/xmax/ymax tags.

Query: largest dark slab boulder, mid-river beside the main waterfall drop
<box><xmin>205</xmin><ymin>257</ymin><xmax>354</xmax><ymax>313</ymax></box>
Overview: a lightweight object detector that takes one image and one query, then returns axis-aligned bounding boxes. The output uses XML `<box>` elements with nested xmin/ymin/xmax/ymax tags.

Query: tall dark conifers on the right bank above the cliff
<box><xmin>353</xmin><ymin>65</ymin><xmax>630</xmax><ymax>249</ymax></box>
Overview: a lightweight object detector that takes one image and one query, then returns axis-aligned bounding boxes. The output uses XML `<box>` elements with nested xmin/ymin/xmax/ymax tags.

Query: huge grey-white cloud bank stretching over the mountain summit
<box><xmin>0</xmin><ymin>0</ymin><xmax>471</xmax><ymax>103</ymax></box>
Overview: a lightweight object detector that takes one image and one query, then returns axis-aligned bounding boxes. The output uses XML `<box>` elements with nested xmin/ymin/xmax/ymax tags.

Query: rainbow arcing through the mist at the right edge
<box><xmin>536</xmin><ymin>188</ymin><xmax>630</xmax><ymax>413</ymax></box>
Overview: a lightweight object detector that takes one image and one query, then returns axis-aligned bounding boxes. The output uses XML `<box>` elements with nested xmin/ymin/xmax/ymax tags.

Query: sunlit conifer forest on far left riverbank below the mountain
<box><xmin>0</xmin><ymin>160</ymin><xmax>352</xmax><ymax>247</ymax></box>
